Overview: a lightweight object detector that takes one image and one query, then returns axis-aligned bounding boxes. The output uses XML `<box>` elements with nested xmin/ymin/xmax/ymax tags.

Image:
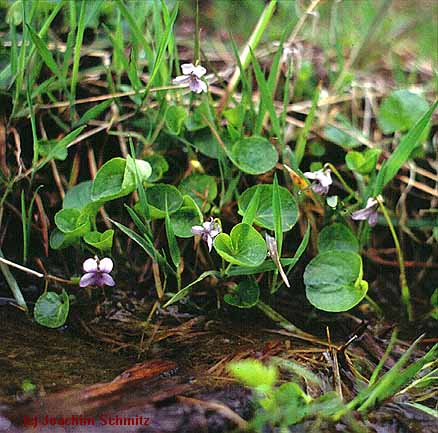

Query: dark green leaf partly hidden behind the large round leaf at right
<box><xmin>318</xmin><ymin>223</ymin><xmax>359</xmax><ymax>254</ymax></box>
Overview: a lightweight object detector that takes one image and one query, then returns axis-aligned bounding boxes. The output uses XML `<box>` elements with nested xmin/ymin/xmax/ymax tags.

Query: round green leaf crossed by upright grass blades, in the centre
<box><xmin>238</xmin><ymin>184</ymin><xmax>298</xmax><ymax>232</ymax></box>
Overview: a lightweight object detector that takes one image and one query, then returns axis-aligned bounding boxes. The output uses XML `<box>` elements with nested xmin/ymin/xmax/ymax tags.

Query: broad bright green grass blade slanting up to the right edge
<box><xmin>374</xmin><ymin>101</ymin><xmax>438</xmax><ymax>195</ymax></box>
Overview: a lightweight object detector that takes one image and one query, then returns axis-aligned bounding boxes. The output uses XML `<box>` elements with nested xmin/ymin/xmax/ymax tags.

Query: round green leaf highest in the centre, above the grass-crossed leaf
<box><xmin>226</xmin><ymin>136</ymin><xmax>278</xmax><ymax>174</ymax></box>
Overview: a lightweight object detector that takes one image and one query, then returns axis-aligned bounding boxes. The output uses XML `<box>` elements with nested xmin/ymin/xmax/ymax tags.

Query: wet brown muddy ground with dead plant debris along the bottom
<box><xmin>0</xmin><ymin>298</ymin><xmax>438</xmax><ymax>433</ymax></box>
